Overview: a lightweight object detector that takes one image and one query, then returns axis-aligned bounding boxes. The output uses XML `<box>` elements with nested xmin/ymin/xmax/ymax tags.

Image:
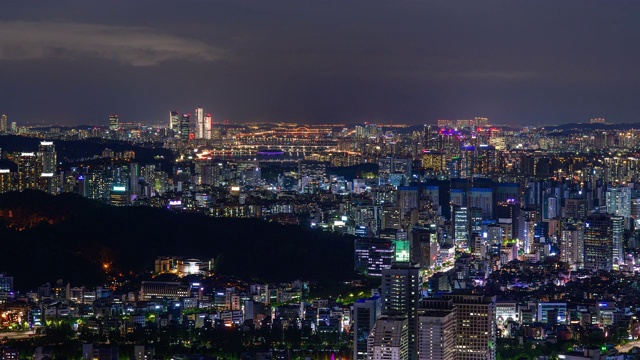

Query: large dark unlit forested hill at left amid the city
<box><xmin>0</xmin><ymin>191</ymin><xmax>353</xmax><ymax>289</ymax></box>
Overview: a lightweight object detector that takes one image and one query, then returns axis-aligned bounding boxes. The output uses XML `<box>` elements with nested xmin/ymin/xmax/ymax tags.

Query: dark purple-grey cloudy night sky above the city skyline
<box><xmin>0</xmin><ymin>0</ymin><xmax>640</xmax><ymax>125</ymax></box>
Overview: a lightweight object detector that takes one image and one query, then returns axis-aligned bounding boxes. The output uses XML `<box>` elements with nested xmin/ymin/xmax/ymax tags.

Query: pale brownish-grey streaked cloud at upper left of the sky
<box><xmin>0</xmin><ymin>22</ymin><xmax>225</xmax><ymax>66</ymax></box>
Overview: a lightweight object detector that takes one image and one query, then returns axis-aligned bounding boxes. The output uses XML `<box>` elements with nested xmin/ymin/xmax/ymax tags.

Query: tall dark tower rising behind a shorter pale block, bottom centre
<box><xmin>382</xmin><ymin>262</ymin><xmax>422</xmax><ymax>360</ymax></box>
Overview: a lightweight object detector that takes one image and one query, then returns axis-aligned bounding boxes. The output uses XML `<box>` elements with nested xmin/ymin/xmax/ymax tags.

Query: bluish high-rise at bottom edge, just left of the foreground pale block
<box><xmin>353</xmin><ymin>296</ymin><xmax>382</xmax><ymax>360</ymax></box>
